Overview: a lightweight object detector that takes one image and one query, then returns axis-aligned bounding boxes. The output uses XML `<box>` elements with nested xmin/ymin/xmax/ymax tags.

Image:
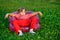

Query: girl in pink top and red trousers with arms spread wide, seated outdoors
<box><xmin>5</xmin><ymin>8</ymin><xmax>42</xmax><ymax>36</ymax></box>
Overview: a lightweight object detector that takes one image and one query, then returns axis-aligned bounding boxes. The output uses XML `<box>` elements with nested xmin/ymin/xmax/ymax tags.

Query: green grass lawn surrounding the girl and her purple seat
<box><xmin>0</xmin><ymin>0</ymin><xmax>60</xmax><ymax>40</ymax></box>
